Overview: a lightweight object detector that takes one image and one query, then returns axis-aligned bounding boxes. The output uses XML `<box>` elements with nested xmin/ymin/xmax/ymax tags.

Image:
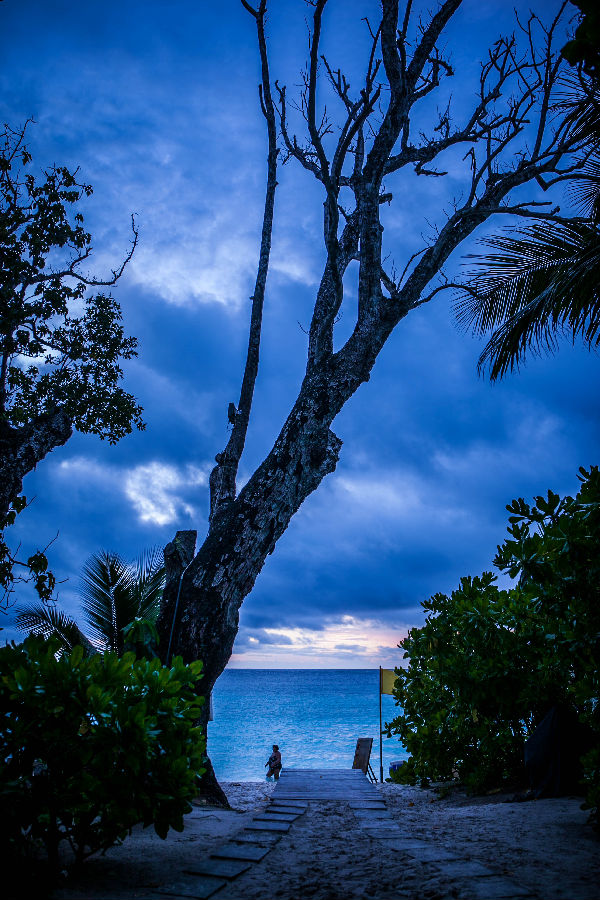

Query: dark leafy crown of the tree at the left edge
<box><xmin>0</xmin><ymin>126</ymin><xmax>143</xmax><ymax>443</ymax></box>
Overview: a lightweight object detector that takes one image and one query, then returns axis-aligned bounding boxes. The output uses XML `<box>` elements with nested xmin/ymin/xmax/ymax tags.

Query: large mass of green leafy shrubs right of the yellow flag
<box><xmin>387</xmin><ymin>467</ymin><xmax>600</xmax><ymax>815</ymax></box>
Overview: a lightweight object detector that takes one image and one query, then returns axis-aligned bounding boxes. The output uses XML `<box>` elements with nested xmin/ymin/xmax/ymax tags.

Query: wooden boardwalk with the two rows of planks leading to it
<box><xmin>144</xmin><ymin>769</ymin><xmax>537</xmax><ymax>900</ymax></box>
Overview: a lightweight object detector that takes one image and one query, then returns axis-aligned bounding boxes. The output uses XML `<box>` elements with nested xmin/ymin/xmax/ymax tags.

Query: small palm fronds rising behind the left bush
<box><xmin>16</xmin><ymin>549</ymin><xmax>165</xmax><ymax>655</ymax></box>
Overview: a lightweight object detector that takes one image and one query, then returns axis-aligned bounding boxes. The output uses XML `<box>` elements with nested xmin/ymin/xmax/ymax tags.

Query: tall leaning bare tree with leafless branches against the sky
<box><xmin>159</xmin><ymin>0</ymin><xmax>580</xmax><ymax>802</ymax></box>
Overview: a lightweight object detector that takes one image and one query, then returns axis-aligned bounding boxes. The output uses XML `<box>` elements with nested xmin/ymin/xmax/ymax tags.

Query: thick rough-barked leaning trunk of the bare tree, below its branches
<box><xmin>158</xmin><ymin>391</ymin><xmax>341</xmax><ymax>799</ymax></box>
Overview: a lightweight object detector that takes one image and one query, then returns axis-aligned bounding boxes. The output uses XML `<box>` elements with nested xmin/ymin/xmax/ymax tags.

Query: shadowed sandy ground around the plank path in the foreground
<box><xmin>44</xmin><ymin>782</ymin><xmax>600</xmax><ymax>900</ymax></box>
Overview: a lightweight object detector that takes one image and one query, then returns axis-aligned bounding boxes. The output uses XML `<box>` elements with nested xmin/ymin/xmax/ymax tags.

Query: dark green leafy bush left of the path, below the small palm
<box><xmin>0</xmin><ymin>636</ymin><xmax>205</xmax><ymax>872</ymax></box>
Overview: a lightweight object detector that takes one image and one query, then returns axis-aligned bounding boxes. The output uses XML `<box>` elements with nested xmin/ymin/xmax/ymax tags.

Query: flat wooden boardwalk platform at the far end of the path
<box><xmin>271</xmin><ymin>769</ymin><xmax>380</xmax><ymax>803</ymax></box>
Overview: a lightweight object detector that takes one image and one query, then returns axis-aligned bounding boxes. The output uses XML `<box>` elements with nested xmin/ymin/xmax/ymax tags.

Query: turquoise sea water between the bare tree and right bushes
<box><xmin>208</xmin><ymin>669</ymin><xmax>407</xmax><ymax>781</ymax></box>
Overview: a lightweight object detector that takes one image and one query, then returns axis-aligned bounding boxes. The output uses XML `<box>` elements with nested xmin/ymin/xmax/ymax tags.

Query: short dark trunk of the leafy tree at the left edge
<box><xmin>0</xmin><ymin>410</ymin><xmax>73</xmax><ymax>516</ymax></box>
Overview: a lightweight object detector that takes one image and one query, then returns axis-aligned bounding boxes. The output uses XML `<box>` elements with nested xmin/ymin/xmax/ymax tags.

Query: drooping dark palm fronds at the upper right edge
<box><xmin>456</xmin><ymin>75</ymin><xmax>600</xmax><ymax>381</ymax></box>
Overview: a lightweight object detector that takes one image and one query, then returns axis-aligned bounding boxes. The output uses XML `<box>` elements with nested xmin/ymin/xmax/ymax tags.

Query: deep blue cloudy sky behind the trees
<box><xmin>0</xmin><ymin>0</ymin><xmax>599</xmax><ymax>668</ymax></box>
